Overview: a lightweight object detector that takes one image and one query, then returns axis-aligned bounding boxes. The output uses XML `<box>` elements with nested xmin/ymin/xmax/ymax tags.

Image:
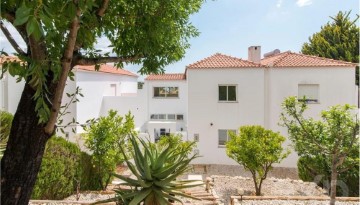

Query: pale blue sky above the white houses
<box><xmin>0</xmin><ymin>0</ymin><xmax>359</xmax><ymax>79</ymax></box>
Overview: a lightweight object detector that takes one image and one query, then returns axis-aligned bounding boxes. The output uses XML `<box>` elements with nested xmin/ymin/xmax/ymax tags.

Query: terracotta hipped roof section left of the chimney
<box><xmin>186</xmin><ymin>53</ymin><xmax>262</xmax><ymax>69</ymax></box>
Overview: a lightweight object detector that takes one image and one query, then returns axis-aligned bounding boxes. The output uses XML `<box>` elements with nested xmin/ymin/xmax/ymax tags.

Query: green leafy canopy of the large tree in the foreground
<box><xmin>0</xmin><ymin>0</ymin><xmax>204</xmax><ymax>123</ymax></box>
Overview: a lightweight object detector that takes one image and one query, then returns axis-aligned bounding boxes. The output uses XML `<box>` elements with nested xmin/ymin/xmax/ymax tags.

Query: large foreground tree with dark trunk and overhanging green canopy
<box><xmin>0</xmin><ymin>0</ymin><xmax>203</xmax><ymax>205</ymax></box>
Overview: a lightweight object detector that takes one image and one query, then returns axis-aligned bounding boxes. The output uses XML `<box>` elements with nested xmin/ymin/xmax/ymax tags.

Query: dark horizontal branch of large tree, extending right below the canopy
<box><xmin>74</xmin><ymin>55</ymin><xmax>142</xmax><ymax>65</ymax></box>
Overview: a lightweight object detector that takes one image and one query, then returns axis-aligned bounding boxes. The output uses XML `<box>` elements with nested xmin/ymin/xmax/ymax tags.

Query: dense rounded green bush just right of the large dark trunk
<box><xmin>32</xmin><ymin>136</ymin><xmax>100</xmax><ymax>200</ymax></box>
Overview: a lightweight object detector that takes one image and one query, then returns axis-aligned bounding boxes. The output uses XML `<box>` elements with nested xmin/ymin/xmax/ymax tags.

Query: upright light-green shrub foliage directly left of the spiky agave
<box><xmin>83</xmin><ymin>110</ymin><xmax>135</xmax><ymax>190</ymax></box>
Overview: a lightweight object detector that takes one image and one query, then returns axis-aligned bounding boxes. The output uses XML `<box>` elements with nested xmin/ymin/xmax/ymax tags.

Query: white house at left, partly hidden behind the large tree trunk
<box><xmin>0</xmin><ymin>60</ymin><xmax>138</xmax><ymax>142</ymax></box>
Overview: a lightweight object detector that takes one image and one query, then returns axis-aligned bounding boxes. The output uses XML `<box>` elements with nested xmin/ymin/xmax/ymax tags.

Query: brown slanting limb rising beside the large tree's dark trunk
<box><xmin>45</xmin><ymin>8</ymin><xmax>81</xmax><ymax>134</ymax></box>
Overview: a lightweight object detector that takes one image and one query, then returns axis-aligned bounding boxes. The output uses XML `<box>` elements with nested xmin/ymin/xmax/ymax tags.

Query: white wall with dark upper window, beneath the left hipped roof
<box><xmin>187</xmin><ymin>68</ymin><xmax>264</xmax><ymax>164</ymax></box>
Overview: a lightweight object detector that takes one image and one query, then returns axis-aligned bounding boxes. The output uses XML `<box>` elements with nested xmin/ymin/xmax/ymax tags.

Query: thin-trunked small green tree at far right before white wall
<box><xmin>281</xmin><ymin>97</ymin><xmax>359</xmax><ymax>205</ymax></box>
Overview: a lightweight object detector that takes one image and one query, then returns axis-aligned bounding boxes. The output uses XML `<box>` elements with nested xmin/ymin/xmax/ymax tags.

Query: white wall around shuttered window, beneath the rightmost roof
<box><xmin>266</xmin><ymin>67</ymin><xmax>356</xmax><ymax>167</ymax></box>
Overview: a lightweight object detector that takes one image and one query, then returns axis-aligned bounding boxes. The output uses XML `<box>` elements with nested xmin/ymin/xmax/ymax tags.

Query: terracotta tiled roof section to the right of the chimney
<box><xmin>260</xmin><ymin>51</ymin><xmax>356</xmax><ymax>67</ymax></box>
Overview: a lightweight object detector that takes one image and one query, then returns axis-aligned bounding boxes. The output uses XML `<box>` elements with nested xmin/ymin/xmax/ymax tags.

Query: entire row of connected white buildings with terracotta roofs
<box><xmin>0</xmin><ymin>46</ymin><xmax>358</xmax><ymax>167</ymax></box>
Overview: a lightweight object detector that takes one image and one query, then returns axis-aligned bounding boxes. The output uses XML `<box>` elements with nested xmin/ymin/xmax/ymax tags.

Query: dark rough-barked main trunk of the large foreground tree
<box><xmin>1</xmin><ymin>83</ymin><xmax>51</xmax><ymax>205</ymax></box>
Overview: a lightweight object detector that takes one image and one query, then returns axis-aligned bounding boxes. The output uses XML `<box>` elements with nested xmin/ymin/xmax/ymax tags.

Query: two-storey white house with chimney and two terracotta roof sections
<box><xmin>186</xmin><ymin>46</ymin><xmax>356</xmax><ymax>167</ymax></box>
